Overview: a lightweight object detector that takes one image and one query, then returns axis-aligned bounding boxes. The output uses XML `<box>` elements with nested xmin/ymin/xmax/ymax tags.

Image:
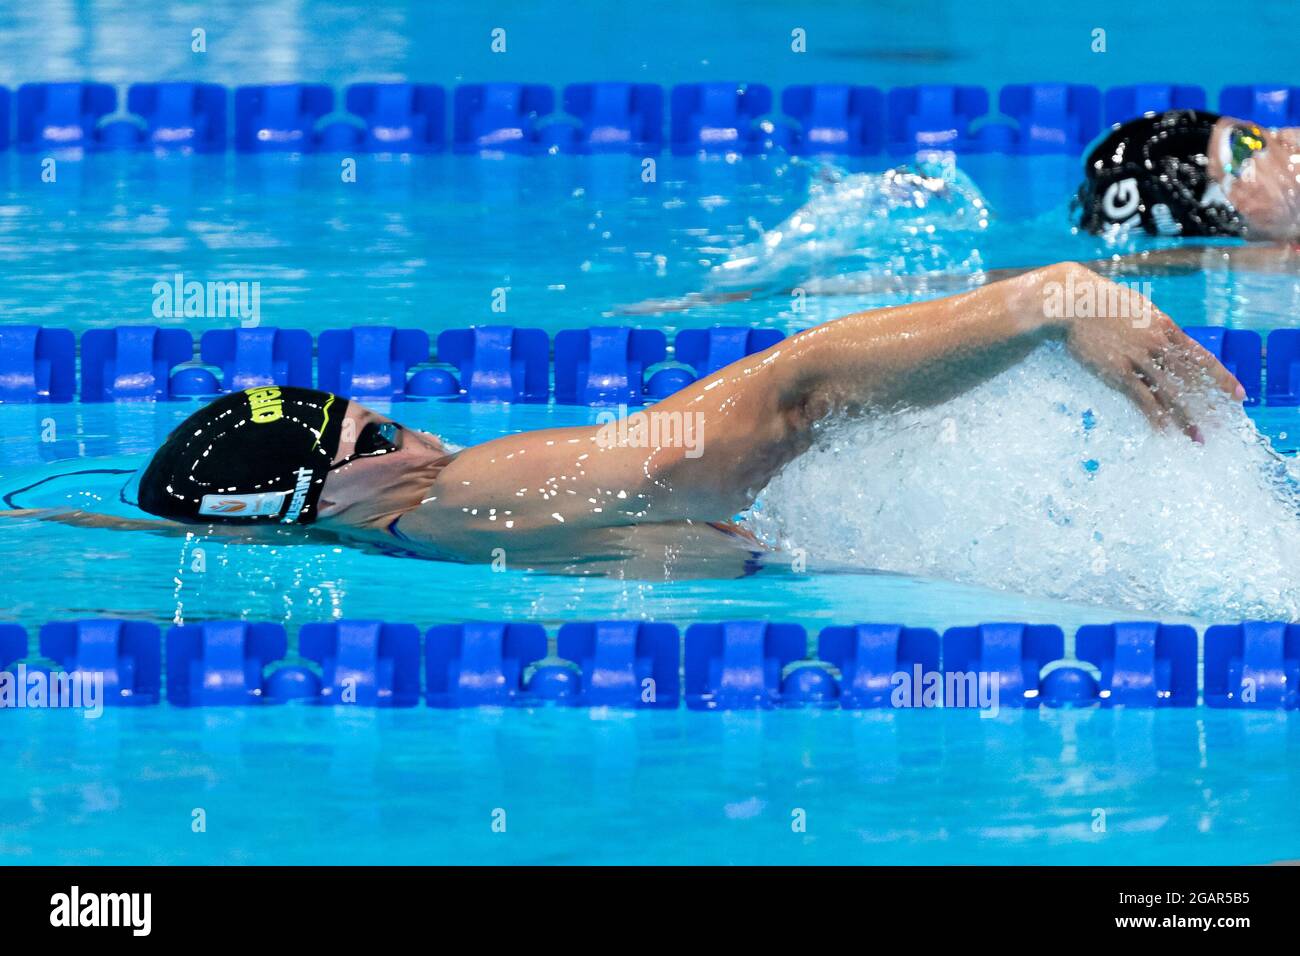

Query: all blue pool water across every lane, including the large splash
<box><xmin>0</xmin><ymin>1</ymin><xmax>1300</xmax><ymax>864</ymax></box>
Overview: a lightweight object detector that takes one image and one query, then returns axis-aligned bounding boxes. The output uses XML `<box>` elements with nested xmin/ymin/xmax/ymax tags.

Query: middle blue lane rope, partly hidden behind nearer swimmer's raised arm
<box><xmin>0</xmin><ymin>325</ymin><xmax>1300</xmax><ymax>407</ymax></box>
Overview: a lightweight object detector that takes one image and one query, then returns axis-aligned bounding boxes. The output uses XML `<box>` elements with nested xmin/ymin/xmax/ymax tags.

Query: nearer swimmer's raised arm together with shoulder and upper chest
<box><xmin>434</xmin><ymin>263</ymin><xmax>1239</xmax><ymax>538</ymax></box>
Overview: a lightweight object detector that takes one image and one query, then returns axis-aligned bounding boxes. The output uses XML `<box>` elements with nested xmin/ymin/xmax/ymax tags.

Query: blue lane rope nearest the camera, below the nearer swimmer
<box><xmin>0</xmin><ymin>619</ymin><xmax>1300</xmax><ymax>710</ymax></box>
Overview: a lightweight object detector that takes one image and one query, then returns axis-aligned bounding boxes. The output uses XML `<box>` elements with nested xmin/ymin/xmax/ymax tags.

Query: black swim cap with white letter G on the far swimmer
<box><xmin>1074</xmin><ymin>109</ymin><xmax>1243</xmax><ymax>235</ymax></box>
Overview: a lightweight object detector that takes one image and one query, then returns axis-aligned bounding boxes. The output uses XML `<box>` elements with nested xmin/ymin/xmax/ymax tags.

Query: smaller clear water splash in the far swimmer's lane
<box><xmin>709</xmin><ymin>153</ymin><xmax>989</xmax><ymax>289</ymax></box>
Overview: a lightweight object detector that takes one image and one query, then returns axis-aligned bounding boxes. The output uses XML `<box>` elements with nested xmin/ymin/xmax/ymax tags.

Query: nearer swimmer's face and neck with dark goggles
<box><xmin>320</xmin><ymin>402</ymin><xmax>449</xmax><ymax>528</ymax></box>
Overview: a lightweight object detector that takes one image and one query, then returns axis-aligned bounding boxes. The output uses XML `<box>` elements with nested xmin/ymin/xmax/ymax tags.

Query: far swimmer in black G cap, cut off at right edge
<box><xmin>616</xmin><ymin>109</ymin><xmax>1300</xmax><ymax>315</ymax></box>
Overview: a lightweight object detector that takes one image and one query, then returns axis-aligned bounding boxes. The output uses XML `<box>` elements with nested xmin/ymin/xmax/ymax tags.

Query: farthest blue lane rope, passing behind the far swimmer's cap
<box><xmin>0</xmin><ymin>82</ymin><xmax>1300</xmax><ymax>156</ymax></box>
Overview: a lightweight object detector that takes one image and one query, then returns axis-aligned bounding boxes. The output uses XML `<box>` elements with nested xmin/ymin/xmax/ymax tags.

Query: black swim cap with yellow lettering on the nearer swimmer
<box><xmin>139</xmin><ymin>386</ymin><xmax>347</xmax><ymax>524</ymax></box>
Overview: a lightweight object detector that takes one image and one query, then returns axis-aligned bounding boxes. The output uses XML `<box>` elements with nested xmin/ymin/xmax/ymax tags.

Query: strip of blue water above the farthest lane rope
<box><xmin>0</xmin><ymin>0</ymin><xmax>1296</xmax><ymax>91</ymax></box>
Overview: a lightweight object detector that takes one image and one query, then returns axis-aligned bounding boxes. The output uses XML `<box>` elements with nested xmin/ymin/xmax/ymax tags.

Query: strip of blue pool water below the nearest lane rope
<box><xmin>0</xmin><ymin>706</ymin><xmax>1300</xmax><ymax>865</ymax></box>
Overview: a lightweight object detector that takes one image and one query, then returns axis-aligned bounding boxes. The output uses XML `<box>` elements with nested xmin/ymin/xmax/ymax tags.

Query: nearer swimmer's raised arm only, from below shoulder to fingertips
<box><xmin>634</xmin><ymin>263</ymin><xmax>1242</xmax><ymax>512</ymax></box>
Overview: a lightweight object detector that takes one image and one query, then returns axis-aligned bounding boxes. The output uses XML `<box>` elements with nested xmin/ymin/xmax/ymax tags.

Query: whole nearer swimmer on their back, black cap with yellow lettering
<box><xmin>20</xmin><ymin>263</ymin><xmax>1244</xmax><ymax>576</ymax></box>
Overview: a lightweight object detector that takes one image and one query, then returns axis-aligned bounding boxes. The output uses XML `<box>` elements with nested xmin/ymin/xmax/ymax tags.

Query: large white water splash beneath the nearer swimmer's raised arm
<box><xmin>749</xmin><ymin>346</ymin><xmax>1300</xmax><ymax>620</ymax></box>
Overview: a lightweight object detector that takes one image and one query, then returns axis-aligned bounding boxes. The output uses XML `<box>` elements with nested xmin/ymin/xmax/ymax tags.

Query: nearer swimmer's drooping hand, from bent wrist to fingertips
<box><xmin>1037</xmin><ymin>263</ymin><xmax>1245</xmax><ymax>441</ymax></box>
